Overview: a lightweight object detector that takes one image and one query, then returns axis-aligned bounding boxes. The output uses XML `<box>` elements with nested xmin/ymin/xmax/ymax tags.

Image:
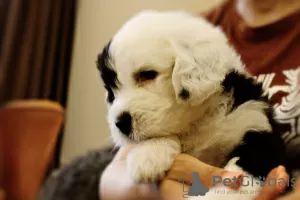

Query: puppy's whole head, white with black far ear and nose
<box><xmin>98</xmin><ymin>11</ymin><xmax>243</xmax><ymax>145</ymax></box>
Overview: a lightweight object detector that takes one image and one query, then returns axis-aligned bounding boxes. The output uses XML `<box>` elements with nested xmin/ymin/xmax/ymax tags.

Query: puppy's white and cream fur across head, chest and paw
<box><xmin>104</xmin><ymin>11</ymin><xmax>270</xmax><ymax>198</ymax></box>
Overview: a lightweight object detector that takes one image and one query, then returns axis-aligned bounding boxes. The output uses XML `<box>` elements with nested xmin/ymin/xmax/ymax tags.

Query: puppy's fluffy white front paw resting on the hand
<box><xmin>127</xmin><ymin>140</ymin><xmax>180</xmax><ymax>183</ymax></box>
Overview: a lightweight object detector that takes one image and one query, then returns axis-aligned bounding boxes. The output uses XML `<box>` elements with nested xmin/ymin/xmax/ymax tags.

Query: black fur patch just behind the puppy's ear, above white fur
<box><xmin>222</xmin><ymin>71</ymin><xmax>266</xmax><ymax>108</ymax></box>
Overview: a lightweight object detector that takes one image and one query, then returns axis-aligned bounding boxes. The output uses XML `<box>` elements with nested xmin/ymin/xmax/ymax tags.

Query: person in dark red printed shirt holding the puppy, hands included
<box><xmin>99</xmin><ymin>0</ymin><xmax>300</xmax><ymax>200</ymax></box>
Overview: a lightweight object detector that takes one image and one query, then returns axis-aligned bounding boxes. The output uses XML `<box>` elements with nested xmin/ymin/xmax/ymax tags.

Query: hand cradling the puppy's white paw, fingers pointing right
<box><xmin>99</xmin><ymin>146</ymin><xmax>240</xmax><ymax>200</ymax></box>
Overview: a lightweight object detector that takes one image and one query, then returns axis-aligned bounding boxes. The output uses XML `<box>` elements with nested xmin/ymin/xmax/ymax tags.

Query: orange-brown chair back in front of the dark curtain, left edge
<box><xmin>0</xmin><ymin>100</ymin><xmax>64</xmax><ymax>200</ymax></box>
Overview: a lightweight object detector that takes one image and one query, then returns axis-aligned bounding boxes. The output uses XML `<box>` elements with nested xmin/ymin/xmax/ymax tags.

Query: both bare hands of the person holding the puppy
<box><xmin>99</xmin><ymin>146</ymin><xmax>300</xmax><ymax>200</ymax></box>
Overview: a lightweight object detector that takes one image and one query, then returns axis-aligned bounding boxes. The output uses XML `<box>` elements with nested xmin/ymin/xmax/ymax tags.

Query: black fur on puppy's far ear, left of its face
<box><xmin>97</xmin><ymin>42</ymin><xmax>118</xmax><ymax>103</ymax></box>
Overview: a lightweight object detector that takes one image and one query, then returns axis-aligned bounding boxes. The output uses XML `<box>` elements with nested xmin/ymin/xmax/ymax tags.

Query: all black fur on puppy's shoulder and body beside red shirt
<box><xmin>222</xmin><ymin>71</ymin><xmax>295</xmax><ymax>192</ymax></box>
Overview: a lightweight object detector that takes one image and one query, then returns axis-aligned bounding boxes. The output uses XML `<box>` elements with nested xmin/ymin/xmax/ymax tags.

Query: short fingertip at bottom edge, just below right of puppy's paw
<box><xmin>159</xmin><ymin>179</ymin><xmax>190</xmax><ymax>200</ymax></box>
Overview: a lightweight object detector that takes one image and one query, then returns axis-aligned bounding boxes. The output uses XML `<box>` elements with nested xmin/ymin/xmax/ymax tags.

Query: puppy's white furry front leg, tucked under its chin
<box><xmin>127</xmin><ymin>136</ymin><xmax>181</xmax><ymax>183</ymax></box>
